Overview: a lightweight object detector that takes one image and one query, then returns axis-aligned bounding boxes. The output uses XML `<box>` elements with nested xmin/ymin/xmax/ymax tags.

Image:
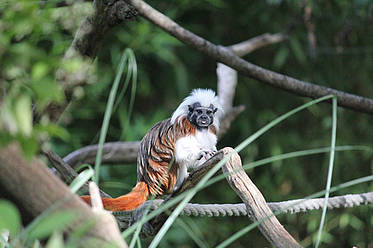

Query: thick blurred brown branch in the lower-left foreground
<box><xmin>0</xmin><ymin>143</ymin><xmax>126</xmax><ymax>247</ymax></box>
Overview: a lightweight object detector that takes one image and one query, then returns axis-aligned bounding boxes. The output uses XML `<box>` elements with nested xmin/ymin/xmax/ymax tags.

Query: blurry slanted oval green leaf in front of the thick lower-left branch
<box><xmin>28</xmin><ymin>210</ymin><xmax>76</xmax><ymax>239</ymax></box>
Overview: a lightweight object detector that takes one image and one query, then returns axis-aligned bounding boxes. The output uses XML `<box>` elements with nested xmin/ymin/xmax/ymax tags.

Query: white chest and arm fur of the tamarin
<box><xmin>175</xmin><ymin>129</ymin><xmax>217</xmax><ymax>189</ymax></box>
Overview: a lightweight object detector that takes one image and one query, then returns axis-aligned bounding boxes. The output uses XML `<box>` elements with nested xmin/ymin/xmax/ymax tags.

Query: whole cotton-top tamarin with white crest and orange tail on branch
<box><xmin>82</xmin><ymin>89</ymin><xmax>222</xmax><ymax>211</ymax></box>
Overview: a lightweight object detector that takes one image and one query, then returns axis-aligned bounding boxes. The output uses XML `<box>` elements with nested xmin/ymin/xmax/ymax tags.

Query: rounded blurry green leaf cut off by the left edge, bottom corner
<box><xmin>0</xmin><ymin>200</ymin><xmax>21</xmax><ymax>238</ymax></box>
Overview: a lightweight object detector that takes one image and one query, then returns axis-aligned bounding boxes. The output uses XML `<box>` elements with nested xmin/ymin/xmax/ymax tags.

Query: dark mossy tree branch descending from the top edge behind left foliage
<box><xmin>44</xmin><ymin>0</ymin><xmax>137</xmax><ymax>122</ymax></box>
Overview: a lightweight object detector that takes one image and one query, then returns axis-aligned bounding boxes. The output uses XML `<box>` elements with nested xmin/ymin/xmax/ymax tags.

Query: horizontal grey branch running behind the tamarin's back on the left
<box><xmin>63</xmin><ymin>141</ymin><xmax>140</xmax><ymax>167</ymax></box>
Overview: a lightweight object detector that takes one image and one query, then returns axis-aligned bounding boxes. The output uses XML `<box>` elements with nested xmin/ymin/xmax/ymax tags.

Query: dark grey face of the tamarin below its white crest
<box><xmin>188</xmin><ymin>102</ymin><xmax>218</xmax><ymax>128</ymax></box>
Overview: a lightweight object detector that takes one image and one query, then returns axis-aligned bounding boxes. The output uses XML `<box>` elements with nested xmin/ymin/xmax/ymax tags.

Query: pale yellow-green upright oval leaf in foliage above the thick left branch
<box><xmin>14</xmin><ymin>95</ymin><xmax>32</xmax><ymax>136</ymax></box>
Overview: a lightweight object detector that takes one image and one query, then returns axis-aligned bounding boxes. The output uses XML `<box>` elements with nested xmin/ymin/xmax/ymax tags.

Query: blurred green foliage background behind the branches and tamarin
<box><xmin>0</xmin><ymin>0</ymin><xmax>373</xmax><ymax>247</ymax></box>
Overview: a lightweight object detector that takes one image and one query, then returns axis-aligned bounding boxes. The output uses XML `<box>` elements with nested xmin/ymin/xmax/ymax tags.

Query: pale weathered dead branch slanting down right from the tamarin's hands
<box><xmin>222</xmin><ymin>147</ymin><xmax>301</xmax><ymax>247</ymax></box>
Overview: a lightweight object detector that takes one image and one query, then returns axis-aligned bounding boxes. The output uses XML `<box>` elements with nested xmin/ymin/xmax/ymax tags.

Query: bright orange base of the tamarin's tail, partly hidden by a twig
<box><xmin>81</xmin><ymin>182</ymin><xmax>149</xmax><ymax>211</ymax></box>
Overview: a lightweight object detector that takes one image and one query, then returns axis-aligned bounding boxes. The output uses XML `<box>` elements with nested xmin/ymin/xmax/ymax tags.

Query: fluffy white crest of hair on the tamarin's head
<box><xmin>171</xmin><ymin>89</ymin><xmax>223</xmax><ymax>129</ymax></box>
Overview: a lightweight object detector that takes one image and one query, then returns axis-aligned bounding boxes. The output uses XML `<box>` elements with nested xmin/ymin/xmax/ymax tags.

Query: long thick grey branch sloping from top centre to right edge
<box><xmin>127</xmin><ymin>0</ymin><xmax>373</xmax><ymax>114</ymax></box>
